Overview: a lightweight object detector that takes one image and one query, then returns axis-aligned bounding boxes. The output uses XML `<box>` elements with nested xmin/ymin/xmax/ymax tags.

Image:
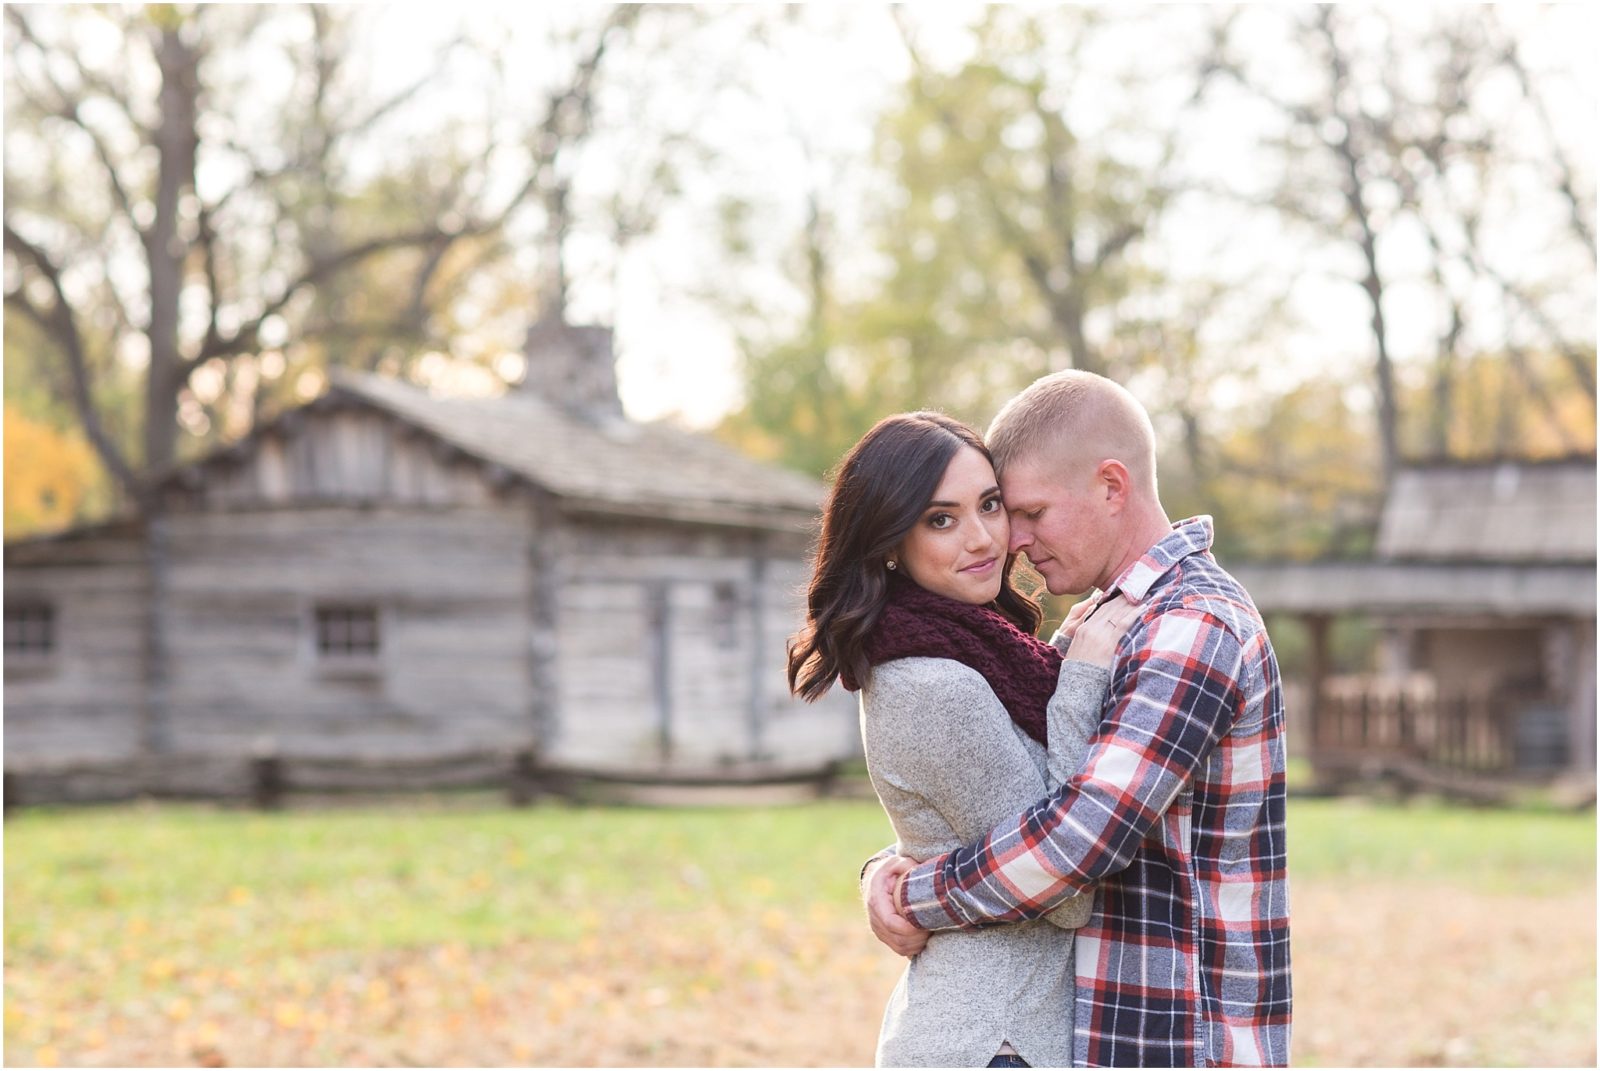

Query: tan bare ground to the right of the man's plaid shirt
<box><xmin>1291</xmin><ymin>885</ymin><xmax>1595</xmax><ymax>1066</ymax></box>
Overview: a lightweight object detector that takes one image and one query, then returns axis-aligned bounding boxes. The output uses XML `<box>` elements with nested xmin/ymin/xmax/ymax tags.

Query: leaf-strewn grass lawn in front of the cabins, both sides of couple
<box><xmin>5</xmin><ymin>799</ymin><xmax>1595</xmax><ymax>1065</ymax></box>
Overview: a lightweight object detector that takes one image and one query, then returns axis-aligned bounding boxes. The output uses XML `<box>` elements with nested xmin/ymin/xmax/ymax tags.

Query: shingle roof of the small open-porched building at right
<box><xmin>1378</xmin><ymin>456</ymin><xmax>1595</xmax><ymax>564</ymax></box>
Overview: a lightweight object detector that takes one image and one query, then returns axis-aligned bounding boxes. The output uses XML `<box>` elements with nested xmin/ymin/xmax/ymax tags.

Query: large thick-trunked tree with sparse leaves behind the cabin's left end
<box><xmin>5</xmin><ymin>5</ymin><xmax>637</xmax><ymax>511</ymax></box>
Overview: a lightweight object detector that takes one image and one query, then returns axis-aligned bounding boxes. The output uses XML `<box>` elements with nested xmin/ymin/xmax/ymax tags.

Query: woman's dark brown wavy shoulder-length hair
<box><xmin>789</xmin><ymin>411</ymin><xmax>1042</xmax><ymax>703</ymax></box>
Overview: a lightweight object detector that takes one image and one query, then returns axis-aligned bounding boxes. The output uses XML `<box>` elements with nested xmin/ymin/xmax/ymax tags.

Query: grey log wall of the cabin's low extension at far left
<box><xmin>5</xmin><ymin>533</ymin><xmax>147</xmax><ymax>765</ymax></box>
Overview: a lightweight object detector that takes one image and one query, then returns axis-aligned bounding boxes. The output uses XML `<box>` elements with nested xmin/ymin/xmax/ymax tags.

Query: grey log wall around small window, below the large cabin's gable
<box><xmin>168</xmin><ymin>506</ymin><xmax>533</xmax><ymax>754</ymax></box>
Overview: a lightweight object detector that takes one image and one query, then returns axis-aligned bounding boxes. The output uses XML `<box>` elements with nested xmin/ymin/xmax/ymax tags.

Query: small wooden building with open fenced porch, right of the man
<box><xmin>1229</xmin><ymin>455</ymin><xmax>1595</xmax><ymax>780</ymax></box>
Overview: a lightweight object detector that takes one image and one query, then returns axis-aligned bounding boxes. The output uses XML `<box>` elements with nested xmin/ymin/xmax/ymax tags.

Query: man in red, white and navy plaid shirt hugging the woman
<box><xmin>864</xmin><ymin>371</ymin><xmax>1290</xmax><ymax>1068</ymax></box>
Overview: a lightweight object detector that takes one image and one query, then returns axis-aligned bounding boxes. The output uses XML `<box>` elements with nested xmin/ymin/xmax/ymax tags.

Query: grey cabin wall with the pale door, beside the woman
<box><xmin>549</xmin><ymin>519</ymin><xmax>853</xmax><ymax>770</ymax></box>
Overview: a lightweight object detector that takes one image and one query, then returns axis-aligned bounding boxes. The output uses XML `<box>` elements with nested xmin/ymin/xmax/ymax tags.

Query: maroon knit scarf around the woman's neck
<box><xmin>842</xmin><ymin>576</ymin><xmax>1061</xmax><ymax>744</ymax></box>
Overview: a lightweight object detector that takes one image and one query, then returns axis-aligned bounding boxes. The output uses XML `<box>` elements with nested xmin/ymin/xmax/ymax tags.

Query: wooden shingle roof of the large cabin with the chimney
<box><xmin>328</xmin><ymin>371</ymin><xmax>824</xmax><ymax>528</ymax></box>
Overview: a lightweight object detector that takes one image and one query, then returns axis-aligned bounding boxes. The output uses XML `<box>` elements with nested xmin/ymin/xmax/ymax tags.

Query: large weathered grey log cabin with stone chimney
<box><xmin>5</xmin><ymin>316</ymin><xmax>859</xmax><ymax>794</ymax></box>
